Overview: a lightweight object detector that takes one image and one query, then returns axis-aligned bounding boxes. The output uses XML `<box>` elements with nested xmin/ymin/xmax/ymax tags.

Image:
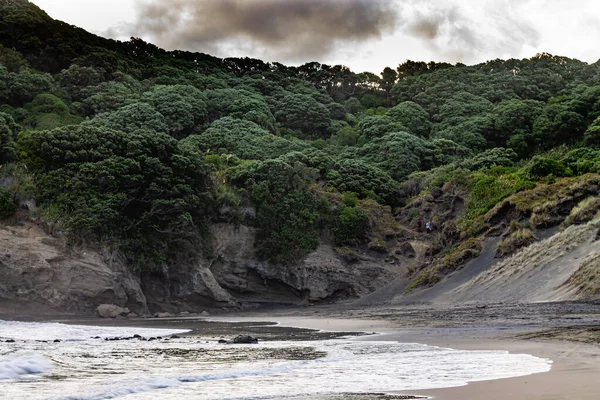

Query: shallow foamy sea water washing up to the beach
<box><xmin>0</xmin><ymin>321</ymin><xmax>551</xmax><ymax>400</ymax></box>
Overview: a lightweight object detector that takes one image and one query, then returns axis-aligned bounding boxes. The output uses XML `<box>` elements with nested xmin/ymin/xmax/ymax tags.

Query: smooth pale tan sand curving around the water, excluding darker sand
<box><xmin>205</xmin><ymin>315</ymin><xmax>600</xmax><ymax>400</ymax></box>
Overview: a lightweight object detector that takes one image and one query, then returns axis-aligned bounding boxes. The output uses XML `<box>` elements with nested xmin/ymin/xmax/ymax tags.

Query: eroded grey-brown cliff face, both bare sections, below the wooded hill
<box><xmin>0</xmin><ymin>219</ymin><xmax>406</xmax><ymax>315</ymax></box>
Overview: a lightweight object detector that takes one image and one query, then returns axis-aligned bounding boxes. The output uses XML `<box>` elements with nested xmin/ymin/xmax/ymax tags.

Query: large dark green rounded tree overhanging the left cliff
<box><xmin>19</xmin><ymin>125</ymin><xmax>210</xmax><ymax>268</ymax></box>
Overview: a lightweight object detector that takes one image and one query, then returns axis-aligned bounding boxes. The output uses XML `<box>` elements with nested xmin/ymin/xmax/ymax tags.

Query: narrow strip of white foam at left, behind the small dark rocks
<box><xmin>0</xmin><ymin>320</ymin><xmax>189</xmax><ymax>341</ymax></box>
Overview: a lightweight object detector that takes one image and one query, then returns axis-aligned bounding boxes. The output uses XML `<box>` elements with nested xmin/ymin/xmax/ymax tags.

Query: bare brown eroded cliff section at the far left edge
<box><xmin>0</xmin><ymin>224</ymin><xmax>148</xmax><ymax>314</ymax></box>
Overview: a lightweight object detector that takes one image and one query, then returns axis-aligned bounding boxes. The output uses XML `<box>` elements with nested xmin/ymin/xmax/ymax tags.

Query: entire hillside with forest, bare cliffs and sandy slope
<box><xmin>0</xmin><ymin>0</ymin><xmax>600</xmax><ymax>313</ymax></box>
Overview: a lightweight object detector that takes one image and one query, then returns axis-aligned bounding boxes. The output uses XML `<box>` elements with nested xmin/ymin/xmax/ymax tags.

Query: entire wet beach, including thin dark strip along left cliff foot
<box><xmin>4</xmin><ymin>303</ymin><xmax>600</xmax><ymax>400</ymax></box>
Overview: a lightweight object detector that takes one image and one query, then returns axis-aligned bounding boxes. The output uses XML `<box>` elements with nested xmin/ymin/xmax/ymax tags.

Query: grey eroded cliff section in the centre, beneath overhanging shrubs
<box><xmin>210</xmin><ymin>224</ymin><xmax>406</xmax><ymax>304</ymax></box>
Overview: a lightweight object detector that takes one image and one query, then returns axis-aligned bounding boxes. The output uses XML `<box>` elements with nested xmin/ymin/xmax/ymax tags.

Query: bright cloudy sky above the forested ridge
<box><xmin>32</xmin><ymin>0</ymin><xmax>600</xmax><ymax>73</ymax></box>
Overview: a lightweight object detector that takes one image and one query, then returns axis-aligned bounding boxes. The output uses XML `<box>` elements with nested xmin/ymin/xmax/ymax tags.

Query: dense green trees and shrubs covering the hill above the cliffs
<box><xmin>0</xmin><ymin>0</ymin><xmax>600</xmax><ymax>272</ymax></box>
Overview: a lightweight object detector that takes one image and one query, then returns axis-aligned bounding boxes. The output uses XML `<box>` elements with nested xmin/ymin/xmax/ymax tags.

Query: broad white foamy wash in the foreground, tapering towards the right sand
<box><xmin>45</xmin><ymin>341</ymin><xmax>551</xmax><ymax>400</ymax></box>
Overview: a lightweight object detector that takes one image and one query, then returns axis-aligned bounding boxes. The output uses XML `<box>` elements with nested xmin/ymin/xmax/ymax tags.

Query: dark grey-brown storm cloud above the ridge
<box><xmin>118</xmin><ymin>0</ymin><xmax>398</xmax><ymax>60</ymax></box>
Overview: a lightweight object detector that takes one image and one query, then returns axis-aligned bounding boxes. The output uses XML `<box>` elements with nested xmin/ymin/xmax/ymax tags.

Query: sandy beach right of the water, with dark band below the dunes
<box><xmin>204</xmin><ymin>304</ymin><xmax>600</xmax><ymax>400</ymax></box>
